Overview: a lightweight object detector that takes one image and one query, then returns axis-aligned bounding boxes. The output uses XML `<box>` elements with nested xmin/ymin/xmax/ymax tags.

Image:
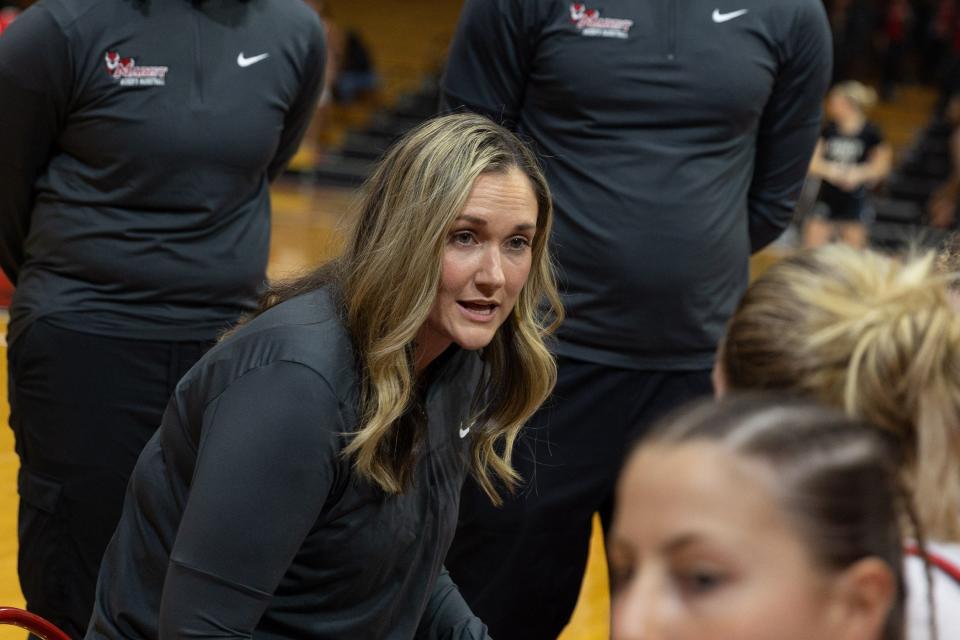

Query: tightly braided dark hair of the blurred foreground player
<box><xmin>641</xmin><ymin>394</ymin><xmax>936</xmax><ymax>640</ymax></box>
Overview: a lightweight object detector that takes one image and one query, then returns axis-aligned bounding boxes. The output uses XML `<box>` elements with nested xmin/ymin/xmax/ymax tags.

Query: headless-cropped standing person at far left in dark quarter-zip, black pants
<box><xmin>0</xmin><ymin>0</ymin><xmax>324</xmax><ymax>638</ymax></box>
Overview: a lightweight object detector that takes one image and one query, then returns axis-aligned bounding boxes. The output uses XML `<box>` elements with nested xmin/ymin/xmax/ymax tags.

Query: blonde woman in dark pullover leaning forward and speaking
<box><xmin>87</xmin><ymin>116</ymin><xmax>561</xmax><ymax>639</ymax></box>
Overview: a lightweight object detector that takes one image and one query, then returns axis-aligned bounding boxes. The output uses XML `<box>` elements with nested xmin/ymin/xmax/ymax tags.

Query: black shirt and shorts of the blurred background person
<box><xmin>817</xmin><ymin>122</ymin><xmax>883</xmax><ymax>221</ymax></box>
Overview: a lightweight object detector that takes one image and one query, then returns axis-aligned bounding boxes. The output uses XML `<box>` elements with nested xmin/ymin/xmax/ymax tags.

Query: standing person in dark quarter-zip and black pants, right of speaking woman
<box><xmin>442</xmin><ymin>0</ymin><xmax>831</xmax><ymax>640</ymax></box>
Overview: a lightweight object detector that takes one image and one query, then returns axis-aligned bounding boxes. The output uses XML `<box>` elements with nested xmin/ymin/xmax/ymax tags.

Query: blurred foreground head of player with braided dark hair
<box><xmin>607</xmin><ymin>396</ymin><xmax>912</xmax><ymax>640</ymax></box>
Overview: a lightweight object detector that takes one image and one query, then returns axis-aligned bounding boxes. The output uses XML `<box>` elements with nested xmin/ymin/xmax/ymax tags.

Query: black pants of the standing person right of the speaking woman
<box><xmin>447</xmin><ymin>359</ymin><xmax>712</xmax><ymax>640</ymax></box>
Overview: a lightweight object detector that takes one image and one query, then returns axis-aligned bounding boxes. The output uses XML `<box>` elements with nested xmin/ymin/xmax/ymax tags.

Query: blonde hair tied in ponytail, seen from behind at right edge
<box><xmin>721</xmin><ymin>245</ymin><xmax>960</xmax><ymax>540</ymax></box>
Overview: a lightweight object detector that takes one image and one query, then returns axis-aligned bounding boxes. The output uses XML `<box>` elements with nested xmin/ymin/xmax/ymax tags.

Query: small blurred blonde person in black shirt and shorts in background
<box><xmin>803</xmin><ymin>81</ymin><xmax>893</xmax><ymax>247</ymax></box>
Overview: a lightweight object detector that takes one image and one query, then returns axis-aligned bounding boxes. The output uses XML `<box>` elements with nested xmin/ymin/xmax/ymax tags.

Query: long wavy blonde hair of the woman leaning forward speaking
<box><xmin>255</xmin><ymin>114</ymin><xmax>563</xmax><ymax>504</ymax></box>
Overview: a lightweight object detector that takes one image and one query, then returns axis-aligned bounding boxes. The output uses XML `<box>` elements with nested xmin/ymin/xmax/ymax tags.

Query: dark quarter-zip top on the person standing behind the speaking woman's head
<box><xmin>443</xmin><ymin>0</ymin><xmax>831</xmax><ymax>370</ymax></box>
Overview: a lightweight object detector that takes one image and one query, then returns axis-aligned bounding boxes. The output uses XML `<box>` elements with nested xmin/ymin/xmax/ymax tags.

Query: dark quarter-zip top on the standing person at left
<box><xmin>0</xmin><ymin>0</ymin><xmax>325</xmax><ymax>340</ymax></box>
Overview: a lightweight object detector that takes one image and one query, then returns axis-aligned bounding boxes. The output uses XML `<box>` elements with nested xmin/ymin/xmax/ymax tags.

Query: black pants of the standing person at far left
<box><xmin>8</xmin><ymin>320</ymin><xmax>211</xmax><ymax>638</ymax></box>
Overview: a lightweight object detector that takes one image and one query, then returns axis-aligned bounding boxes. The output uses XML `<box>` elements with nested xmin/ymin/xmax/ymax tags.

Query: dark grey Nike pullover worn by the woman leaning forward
<box><xmin>87</xmin><ymin>290</ymin><xmax>486</xmax><ymax>640</ymax></box>
